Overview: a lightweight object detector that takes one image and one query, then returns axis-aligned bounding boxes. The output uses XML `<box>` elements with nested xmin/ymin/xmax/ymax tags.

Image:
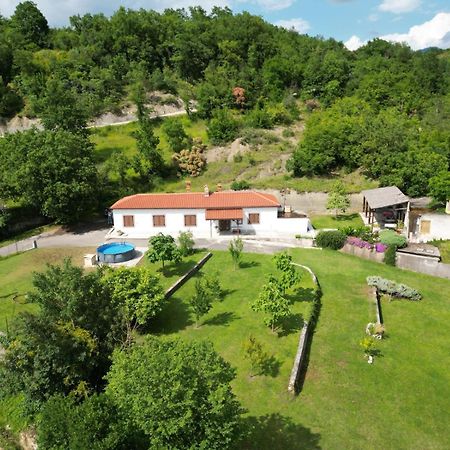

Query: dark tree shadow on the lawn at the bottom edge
<box><xmin>235</xmin><ymin>413</ymin><xmax>321</xmax><ymax>450</ymax></box>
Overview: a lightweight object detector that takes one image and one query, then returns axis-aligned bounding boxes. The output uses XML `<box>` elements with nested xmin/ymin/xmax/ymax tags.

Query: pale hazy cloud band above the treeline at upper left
<box><xmin>0</xmin><ymin>0</ymin><xmax>230</xmax><ymax>26</ymax></box>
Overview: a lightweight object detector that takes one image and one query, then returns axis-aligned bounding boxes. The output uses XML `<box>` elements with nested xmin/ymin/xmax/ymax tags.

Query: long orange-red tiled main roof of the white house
<box><xmin>111</xmin><ymin>191</ymin><xmax>280</xmax><ymax>209</ymax></box>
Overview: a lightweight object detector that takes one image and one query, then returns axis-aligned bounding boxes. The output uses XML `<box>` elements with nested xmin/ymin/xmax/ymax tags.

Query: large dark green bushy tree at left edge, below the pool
<box><xmin>0</xmin><ymin>260</ymin><xmax>125</xmax><ymax>411</ymax></box>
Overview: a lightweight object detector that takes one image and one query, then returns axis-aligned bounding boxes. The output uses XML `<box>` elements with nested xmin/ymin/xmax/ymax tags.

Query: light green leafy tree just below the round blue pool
<box><xmin>103</xmin><ymin>267</ymin><xmax>165</xmax><ymax>343</ymax></box>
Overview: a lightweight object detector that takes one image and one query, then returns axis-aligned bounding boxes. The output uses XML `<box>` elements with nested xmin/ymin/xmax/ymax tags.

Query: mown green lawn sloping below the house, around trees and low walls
<box><xmin>0</xmin><ymin>249</ymin><xmax>450</xmax><ymax>450</ymax></box>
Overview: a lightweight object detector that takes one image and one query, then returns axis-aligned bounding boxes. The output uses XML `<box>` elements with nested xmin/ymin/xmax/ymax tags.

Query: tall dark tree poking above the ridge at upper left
<box><xmin>11</xmin><ymin>1</ymin><xmax>49</xmax><ymax>47</ymax></box>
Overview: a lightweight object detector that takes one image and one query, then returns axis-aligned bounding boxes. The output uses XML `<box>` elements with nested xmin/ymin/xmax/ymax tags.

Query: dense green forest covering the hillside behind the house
<box><xmin>0</xmin><ymin>1</ymin><xmax>450</xmax><ymax>223</ymax></box>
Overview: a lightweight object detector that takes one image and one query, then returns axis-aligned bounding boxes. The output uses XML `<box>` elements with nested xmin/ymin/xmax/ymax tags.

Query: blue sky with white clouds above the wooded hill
<box><xmin>0</xmin><ymin>0</ymin><xmax>450</xmax><ymax>50</ymax></box>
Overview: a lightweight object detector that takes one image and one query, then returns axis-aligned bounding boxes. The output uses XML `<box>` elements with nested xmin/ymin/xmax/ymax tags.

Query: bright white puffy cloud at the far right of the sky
<box><xmin>380</xmin><ymin>13</ymin><xmax>450</xmax><ymax>50</ymax></box>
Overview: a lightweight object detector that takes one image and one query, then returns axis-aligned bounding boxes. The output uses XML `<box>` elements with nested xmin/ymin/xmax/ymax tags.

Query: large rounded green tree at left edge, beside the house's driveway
<box><xmin>0</xmin><ymin>130</ymin><xmax>97</xmax><ymax>224</ymax></box>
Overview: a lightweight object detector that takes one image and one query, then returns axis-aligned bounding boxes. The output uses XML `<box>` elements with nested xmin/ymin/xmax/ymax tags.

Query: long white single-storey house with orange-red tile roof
<box><xmin>111</xmin><ymin>187</ymin><xmax>312</xmax><ymax>238</ymax></box>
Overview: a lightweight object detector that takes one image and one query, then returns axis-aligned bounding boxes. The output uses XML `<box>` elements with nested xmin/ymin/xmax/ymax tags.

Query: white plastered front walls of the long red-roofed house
<box><xmin>113</xmin><ymin>207</ymin><xmax>311</xmax><ymax>238</ymax></box>
